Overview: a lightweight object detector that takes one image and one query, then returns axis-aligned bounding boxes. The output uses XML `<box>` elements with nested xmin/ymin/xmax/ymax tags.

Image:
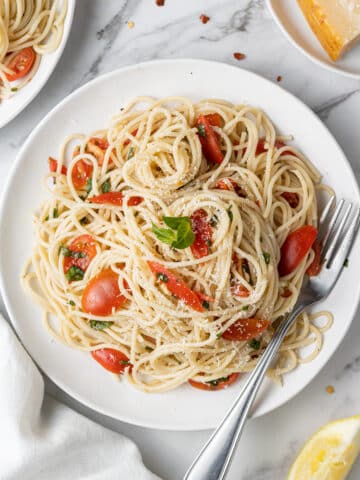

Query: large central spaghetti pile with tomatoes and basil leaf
<box><xmin>22</xmin><ymin>97</ymin><xmax>332</xmax><ymax>392</ymax></box>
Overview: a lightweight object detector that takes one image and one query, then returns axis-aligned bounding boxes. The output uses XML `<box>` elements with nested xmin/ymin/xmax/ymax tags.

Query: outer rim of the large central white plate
<box><xmin>0</xmin><ymin>58</ymin><xmax>360</xmax><ymax>431</ymax></box>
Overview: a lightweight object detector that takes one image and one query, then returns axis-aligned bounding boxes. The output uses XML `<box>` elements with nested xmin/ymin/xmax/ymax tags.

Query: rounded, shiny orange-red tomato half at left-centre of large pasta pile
<box><xmin>81</xmin><ymin>268</ymin><xmax>126</xmax><ymax>316</ymax></box>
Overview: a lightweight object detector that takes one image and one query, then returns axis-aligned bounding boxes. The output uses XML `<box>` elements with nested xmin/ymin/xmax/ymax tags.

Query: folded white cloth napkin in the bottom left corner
<box><xmin>0</xmin><ymin>316</ymin><xmax>158</xmax><ymax>480</ymax></box>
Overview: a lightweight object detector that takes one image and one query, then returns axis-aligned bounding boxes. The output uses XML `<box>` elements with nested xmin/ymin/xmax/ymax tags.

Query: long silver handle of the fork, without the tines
<box><xmin>184</xmin><ymin>301</ymin><xmax>306</xmax><ymax>480</ymax></box>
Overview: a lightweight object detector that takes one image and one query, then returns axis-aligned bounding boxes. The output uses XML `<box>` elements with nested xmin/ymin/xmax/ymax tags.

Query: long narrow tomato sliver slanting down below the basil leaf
<box><xmin>148</xmin><ymin>262</ymin><xmax>204</xmax><ymax>312</ymax></box>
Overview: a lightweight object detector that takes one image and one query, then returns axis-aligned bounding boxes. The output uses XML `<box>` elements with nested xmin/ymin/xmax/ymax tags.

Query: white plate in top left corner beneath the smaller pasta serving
<box><xmin>0</xmin><ymin>0</ymin><xmax>76</xmax><ymax>128</ymax></box>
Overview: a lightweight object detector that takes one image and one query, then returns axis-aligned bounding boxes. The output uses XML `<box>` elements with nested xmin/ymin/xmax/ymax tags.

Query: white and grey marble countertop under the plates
<box><xmin>0</xmin><ymin>0</ymin><xmax>360</xmax><ymax>480</ymax></box>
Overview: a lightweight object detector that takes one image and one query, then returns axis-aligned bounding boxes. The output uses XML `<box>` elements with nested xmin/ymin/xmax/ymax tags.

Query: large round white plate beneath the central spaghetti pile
<box><xmin>0</xmin><ymin>60</ymin><xmax>360</xmax><ymax>430</ymax></box>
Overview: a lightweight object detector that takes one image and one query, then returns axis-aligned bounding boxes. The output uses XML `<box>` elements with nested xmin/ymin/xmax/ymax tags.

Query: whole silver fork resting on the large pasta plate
<box><xmin>184</xmin><ymin>197</ymin><xmax>360</xmax><ymax>480</ymax></box>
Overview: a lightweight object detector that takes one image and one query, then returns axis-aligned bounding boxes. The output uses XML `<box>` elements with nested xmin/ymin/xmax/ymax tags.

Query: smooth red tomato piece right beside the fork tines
<box><xmin>278</xmin><ymin>225</ymin><xmax>318</xmax><ymax>277</ymax></box>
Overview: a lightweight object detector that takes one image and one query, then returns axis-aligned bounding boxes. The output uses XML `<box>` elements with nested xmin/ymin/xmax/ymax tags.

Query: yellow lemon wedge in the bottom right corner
<box><xmin>287</xmin><ymin>415</ymin><xmax>360</xmax><ymax>480</ymax></box>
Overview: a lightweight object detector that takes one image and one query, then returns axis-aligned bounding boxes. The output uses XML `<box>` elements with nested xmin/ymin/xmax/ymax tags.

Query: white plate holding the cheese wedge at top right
<box><xmin>267</xmin><ymin>0</ymin><xmax>360</xmax><ymax>78</ymax></box>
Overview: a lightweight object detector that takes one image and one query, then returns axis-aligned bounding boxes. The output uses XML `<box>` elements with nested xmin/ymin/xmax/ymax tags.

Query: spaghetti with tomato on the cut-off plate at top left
<box><xmin>0</xmin><ymin>0</ymin><xmax>67</xmax><ymax>100</ymax></box>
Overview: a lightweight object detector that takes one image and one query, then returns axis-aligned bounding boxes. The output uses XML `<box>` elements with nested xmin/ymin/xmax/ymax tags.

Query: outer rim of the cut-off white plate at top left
<box><xmin>0</xmin><ymin>0</ymin><xmax>76</xmax><ymax>128</ymax></box>
